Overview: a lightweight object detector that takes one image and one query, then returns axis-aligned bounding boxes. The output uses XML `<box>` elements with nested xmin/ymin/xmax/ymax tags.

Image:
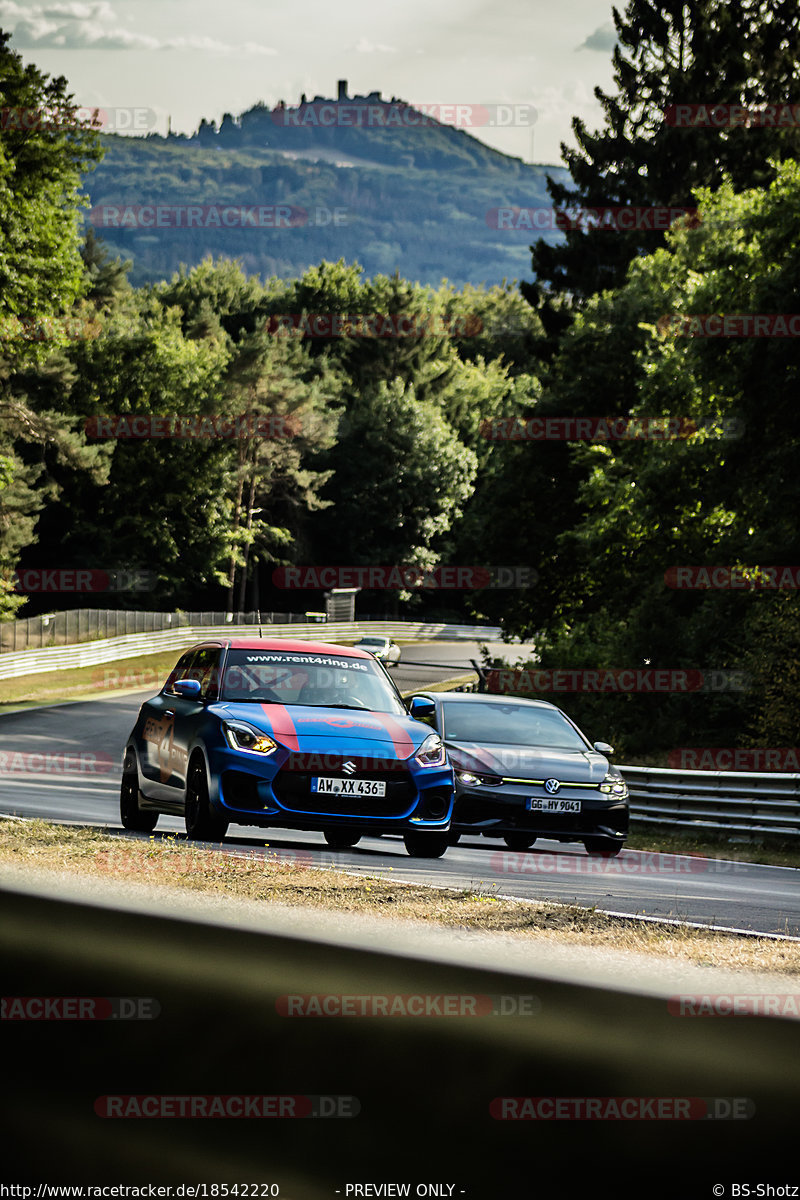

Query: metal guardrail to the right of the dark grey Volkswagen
<box><xmin>619</xmin><ymin>764</ymin><xmax>800</xmax><ymax>836</ymax></box>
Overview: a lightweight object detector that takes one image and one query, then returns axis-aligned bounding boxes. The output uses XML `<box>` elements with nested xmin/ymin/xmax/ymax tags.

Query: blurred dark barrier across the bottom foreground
<box><xmin>0</xmin><ymin>872</ymin><xmax>800</xmax><ymax>1200</ymax></box>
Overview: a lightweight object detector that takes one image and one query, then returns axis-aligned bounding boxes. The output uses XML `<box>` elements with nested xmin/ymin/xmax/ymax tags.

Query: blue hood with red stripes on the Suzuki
<box><xmin>209</xmin><ymin>703</ymin><xmax>431</xmax><ymax>758</ymax></box>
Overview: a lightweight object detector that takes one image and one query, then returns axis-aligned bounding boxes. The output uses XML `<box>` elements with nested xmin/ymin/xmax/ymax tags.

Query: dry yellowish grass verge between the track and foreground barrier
<box><xmin>0</xmin><ymin>818</ymin><xmax>800</xmax><ymax>989</ymax></box>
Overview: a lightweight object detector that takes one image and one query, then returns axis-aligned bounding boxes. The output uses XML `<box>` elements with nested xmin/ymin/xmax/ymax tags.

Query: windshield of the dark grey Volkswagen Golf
<box><xmin>441</xmin><ymin>701</ymin><xmax>588</xmax><ymax>750</ymax></box>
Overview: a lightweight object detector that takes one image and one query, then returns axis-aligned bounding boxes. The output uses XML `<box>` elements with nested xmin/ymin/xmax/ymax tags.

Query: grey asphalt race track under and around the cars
<box><xmin>0</xmin><ymin>643</ymin><xmax>800</xmax><ymax>936</ymax></box>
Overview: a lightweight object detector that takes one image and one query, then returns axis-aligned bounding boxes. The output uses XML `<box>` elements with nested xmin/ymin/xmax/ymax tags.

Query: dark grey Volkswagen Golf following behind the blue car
<box><xmin>410</xmin><ymin>691</ymin><xmax>628</xmax><ymax>854</ymax></box>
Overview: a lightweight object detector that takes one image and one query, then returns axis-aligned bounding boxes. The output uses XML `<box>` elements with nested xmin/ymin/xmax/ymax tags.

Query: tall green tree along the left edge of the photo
<box><xmin>0</xmin><ymin>30</ymin><xmax>103</xmax><ymax>620</ymax></box>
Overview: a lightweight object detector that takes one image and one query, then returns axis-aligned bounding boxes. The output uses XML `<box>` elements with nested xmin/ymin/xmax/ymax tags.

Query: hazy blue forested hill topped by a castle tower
<box><xmin>86</xmin><ymin>85</ymin><xmax>566</xmax><ymax>286</ymax></box>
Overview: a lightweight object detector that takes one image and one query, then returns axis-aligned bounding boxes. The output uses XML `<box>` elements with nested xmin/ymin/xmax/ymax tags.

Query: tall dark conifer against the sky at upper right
<box><xmin>522</xmin><ymin>0</ymin><xmax>800</xmax><ymax>309</ymax></box>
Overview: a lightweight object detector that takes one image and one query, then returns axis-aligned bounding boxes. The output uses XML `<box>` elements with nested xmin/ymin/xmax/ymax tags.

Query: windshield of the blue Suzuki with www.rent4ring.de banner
<box><xmin>219</xmin><ymin>649</ymin><xmax>408</xmax><ymax>715</ymax></box>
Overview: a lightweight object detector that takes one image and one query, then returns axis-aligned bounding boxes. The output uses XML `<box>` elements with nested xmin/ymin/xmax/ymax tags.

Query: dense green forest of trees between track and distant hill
<box><xmin>0</xmin><ymin>0</ymin><xmax>800</xmax><ymax>757</ymax></box>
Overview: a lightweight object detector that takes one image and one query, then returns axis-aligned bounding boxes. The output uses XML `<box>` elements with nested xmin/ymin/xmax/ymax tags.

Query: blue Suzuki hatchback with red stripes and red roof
<box><xmin>120</xmin><ymin>637</ymin><xmax>453</xmax><ymax>858</ymax></box>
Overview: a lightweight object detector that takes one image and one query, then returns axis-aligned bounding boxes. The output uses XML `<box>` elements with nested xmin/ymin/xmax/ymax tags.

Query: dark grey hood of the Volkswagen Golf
<box><xmin>445</xmin><ymin>742</ymin><xmax>608</xmax><ymax>784</ymax></box>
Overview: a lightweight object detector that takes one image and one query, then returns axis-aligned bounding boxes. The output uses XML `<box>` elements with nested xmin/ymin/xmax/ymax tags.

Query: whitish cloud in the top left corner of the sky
<box><xmin>0</xmin><ymin>0</ymin><xmax>277</xmax><ymax>55</ymax></box>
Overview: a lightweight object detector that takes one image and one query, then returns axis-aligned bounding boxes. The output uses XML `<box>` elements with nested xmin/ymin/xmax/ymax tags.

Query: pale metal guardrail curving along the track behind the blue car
<box><xmin>0</xmin><ymin>620</ymin><xmax>500</xmax><ymax>679</ymax></box>
